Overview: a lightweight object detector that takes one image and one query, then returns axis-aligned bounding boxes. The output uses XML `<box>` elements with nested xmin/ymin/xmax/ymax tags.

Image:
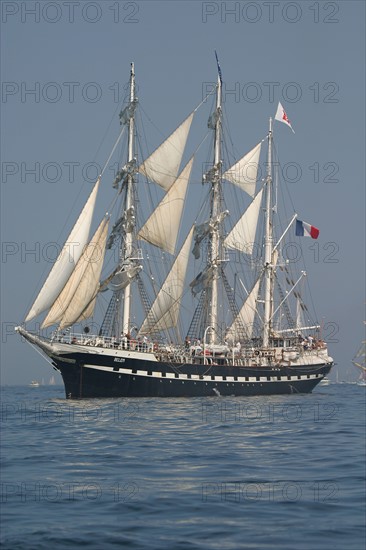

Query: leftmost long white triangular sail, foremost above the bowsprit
<box><xmin>25</xmin><ymin>178</ymin><xmax>100</xmax><ymax>321</ymax></box>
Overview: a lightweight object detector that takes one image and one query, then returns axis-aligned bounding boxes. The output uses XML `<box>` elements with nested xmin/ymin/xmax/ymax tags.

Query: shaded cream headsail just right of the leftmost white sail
<box><xmin>42</xmin><ymin>218</ymin><xmax>109</xmax><ymax>329</ymax></box>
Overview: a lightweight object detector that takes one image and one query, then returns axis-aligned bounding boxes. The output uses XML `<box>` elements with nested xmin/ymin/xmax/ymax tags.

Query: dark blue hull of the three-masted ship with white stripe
<box><xmin>52</xmin><ymin>353</ymin><xmax>332</xmax><ymax>399</ymax></box>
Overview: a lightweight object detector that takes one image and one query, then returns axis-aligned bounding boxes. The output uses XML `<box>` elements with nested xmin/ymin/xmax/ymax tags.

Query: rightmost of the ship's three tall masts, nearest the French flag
<box><xmin>263</xmin><ymin>118</ymin><xmax>273</xmax><ymax>347</ymax></box>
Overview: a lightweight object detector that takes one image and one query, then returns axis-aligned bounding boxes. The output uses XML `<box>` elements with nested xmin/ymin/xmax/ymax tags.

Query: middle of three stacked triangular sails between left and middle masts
<box><xmin>137</xmin><ymin>157</ymin><xmax>193</xmax><ymax>254</ymax></box>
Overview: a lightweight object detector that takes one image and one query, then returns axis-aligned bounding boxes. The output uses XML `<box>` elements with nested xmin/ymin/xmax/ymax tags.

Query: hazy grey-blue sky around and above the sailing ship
<box><xmin>1</xmin><ymin>0</ymin><xmax>365</xmax><ymax>384</ymax></box>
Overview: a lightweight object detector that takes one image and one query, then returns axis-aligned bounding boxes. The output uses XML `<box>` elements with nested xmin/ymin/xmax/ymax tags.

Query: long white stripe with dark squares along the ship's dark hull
<box><xmin>83</xmin><ymin>365</ymin><xmax>324</xmax><ymax>383</ymax></box>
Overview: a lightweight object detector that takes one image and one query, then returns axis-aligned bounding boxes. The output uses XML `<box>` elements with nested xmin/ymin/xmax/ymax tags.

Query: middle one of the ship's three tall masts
<box><xmin>208</xmin><ymin>75</ymin><xmax>221</xmax><ymax>344</ymax></box>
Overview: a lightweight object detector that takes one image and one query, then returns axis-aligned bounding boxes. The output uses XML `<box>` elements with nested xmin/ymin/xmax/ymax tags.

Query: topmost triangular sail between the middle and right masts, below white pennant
<box><xmin>223</xmin><ymin>142</ymin><xmax>262</xmax><ymax>197</ymax></box>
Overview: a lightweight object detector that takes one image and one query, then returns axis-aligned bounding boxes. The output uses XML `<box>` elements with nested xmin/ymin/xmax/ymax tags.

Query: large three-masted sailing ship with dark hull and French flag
<box><xmin>16</xmin><ymin>60</ymin><xmax>333</xmax><ymax>398</ymax></box>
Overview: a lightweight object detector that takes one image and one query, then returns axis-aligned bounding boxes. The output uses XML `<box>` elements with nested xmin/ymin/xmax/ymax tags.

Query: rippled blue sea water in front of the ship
<box><xmin>1</xmin><ymin>384</ymin><xmax>366</xmax><ymax>550</ymax></box>
